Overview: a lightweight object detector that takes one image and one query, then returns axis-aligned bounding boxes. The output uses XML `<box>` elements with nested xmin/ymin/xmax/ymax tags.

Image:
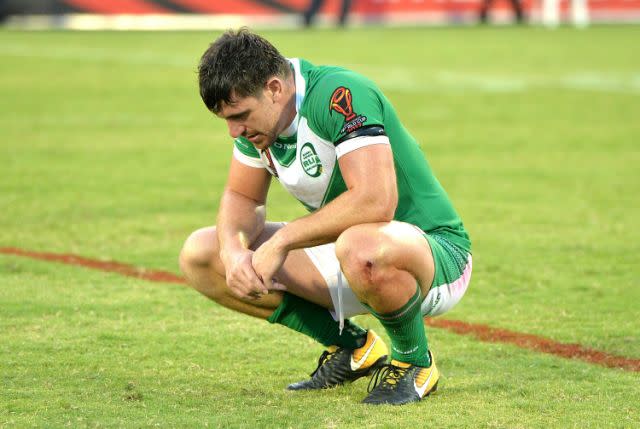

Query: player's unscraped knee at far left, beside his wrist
<box><xmin>179</xmin><ymin>227</ymin><xmax>224</xmax><ymax>275</ymax></box>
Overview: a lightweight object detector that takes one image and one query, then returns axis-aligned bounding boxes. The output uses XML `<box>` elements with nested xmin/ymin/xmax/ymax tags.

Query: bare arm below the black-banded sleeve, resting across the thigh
<box><xmin>253</xmin><ymin>144</ymin><xmax>398</xmax><ymax>287</ymax></box>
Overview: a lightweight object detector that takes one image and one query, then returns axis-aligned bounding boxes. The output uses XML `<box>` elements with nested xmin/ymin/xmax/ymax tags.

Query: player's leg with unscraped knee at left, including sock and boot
<box><xmin>180</xmin><ymin>223</ymin><xmax>387</xmax><ymax>390</ymax></box>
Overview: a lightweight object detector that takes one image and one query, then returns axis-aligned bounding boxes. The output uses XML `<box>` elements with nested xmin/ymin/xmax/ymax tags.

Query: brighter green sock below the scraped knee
<box><xmin>364</xmin><ymin>286</ymin><xmax>431</xmax><ymax>367</ymax></box>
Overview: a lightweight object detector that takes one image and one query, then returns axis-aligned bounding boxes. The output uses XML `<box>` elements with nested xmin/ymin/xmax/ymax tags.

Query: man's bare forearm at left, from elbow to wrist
<box><xmin>216</xmin><ymin>189</ymin><xmax>266</xmax><ymax>265</ymax></box>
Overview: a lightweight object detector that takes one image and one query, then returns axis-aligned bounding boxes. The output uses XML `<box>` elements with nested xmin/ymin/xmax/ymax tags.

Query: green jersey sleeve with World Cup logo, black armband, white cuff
<box><xmin>313</xmin><ymin>71</ymin><xmax>389</xmax><ymax>158</ymax></box>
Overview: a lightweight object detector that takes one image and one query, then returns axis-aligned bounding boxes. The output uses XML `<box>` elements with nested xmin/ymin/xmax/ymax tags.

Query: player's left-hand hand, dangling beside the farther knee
<box><xmin>225</xmin><ymin>250</ymin><xmax>278</xmax><ymax>299</ymax></box>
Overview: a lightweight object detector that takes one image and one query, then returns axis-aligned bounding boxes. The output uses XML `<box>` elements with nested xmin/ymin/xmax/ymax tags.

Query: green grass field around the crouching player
<box><xmin>0</xmin><ymin>26</ymin><xmax>640</xmax><ymax>428</ymax></box>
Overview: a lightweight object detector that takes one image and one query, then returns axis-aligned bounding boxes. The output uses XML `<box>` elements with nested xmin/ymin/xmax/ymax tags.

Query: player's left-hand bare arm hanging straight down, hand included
<box><xmin>216</xmin><ymin>158</ymin><xmax>271</xmax><ymax>298</ymax></box>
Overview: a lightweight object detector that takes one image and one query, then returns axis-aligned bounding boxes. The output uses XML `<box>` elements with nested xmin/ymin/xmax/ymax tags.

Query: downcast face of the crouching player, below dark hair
<box><xmin>217</xmin><ymin>90</ymin><xmax>281</xmax><ymax>150</ymax></box>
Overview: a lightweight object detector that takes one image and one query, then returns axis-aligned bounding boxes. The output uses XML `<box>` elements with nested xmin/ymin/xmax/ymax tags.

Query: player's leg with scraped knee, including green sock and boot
<box><xmin>336</xmin><ymin>222</ymin><xmax>438</xmax><ymax>404</ymax></box>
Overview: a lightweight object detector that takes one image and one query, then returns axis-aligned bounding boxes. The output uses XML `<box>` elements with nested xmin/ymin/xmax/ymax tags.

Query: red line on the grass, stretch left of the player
<box><xmin>0</xmin><ymin>247</ymin><xmax>186</xmax><ymax>284</ymax></box>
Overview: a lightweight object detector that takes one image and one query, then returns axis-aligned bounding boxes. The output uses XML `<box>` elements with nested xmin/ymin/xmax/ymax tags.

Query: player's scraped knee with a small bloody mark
<box><xmin>336</xmin><ymin>224</ymin><xmax>393</xmax><ymax>290</ymax></box>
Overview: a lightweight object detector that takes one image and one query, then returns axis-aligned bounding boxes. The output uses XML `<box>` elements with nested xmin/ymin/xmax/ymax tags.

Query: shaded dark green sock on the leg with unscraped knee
<box><xmin>267</xmin><ymin>292</ymin><xmax>367</xmax><ymax>349</ymax></box>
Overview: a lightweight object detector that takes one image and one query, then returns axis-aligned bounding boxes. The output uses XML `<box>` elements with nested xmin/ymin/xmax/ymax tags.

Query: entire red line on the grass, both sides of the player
<box><xmin>0</xmin><ymin>247</ymin><xmax>640</xmax><ymax>372</ymax></box>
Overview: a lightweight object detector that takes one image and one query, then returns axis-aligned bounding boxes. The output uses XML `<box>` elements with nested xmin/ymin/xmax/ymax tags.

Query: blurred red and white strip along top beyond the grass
<box><xmin>0</xmin><ymin>0</ymin><xmax>640</xmax><ymax>29</ymax></box>
